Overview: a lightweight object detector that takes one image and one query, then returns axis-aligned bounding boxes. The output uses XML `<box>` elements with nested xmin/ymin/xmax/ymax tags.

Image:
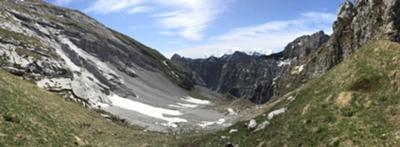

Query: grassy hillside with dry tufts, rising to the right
<box><xmin>182</xmin><ymin>41</ymin><xmax>400</xmax><ymax>146</ymax></box>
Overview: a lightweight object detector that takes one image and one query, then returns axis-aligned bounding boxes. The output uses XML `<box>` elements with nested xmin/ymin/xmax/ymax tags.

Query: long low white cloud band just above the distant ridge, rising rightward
<box><xmin>170</xmin><ymin>12</ymin><xmax>336</xmax><ymax>58</ymax></box>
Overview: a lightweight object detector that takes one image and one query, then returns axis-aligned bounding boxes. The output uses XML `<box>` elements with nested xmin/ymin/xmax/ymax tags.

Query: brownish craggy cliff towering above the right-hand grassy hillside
<box><xmin>275</xmin><ymin>0</ymin><xmax>400</xmax><ymax>95</ymax></box>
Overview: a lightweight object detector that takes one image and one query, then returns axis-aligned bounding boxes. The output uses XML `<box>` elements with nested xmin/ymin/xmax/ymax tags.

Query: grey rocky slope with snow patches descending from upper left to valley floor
<box><xmin>0</xmin><ymin>0</ymin><xmax>236</xmax><ymax>131</ymax></box>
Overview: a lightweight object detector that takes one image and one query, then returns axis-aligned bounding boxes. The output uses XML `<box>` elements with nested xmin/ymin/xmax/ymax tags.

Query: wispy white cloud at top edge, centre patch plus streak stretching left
<box><xmin>86</xmin><ymin>0</ymin><xmax>224</xmax><ymax>41</ymax></box>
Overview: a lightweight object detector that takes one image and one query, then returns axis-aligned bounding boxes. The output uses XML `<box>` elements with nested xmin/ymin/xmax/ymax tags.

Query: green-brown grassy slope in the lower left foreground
<box><xmin>0</xmin><ymin>70</ymin><xmax>170</xmax><ymax>146</ymax></box>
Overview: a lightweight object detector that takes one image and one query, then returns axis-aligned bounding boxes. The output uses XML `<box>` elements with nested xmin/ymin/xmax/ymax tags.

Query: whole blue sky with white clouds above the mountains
<box><xmin>47</xmin><ymin>0</ymin><xmax>343</xmax><ymax>58</ymax></box>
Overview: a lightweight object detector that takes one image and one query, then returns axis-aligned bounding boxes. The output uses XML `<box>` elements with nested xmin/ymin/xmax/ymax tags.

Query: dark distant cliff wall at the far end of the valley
<box><xmin>171</xmin><ymin>31</ymin><xmax>329</xmax><ymax>103</ymax></box>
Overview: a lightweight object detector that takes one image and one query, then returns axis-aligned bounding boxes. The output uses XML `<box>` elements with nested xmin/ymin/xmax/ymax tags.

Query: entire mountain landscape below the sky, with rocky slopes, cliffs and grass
<box><xmin>0</xmin><ymin>0</ymin><xmax>400</xmax><ymax>146</ymax></box>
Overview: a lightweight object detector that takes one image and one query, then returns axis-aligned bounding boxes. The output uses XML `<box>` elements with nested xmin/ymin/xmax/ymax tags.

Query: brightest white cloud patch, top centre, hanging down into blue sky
<box><xmin>155</xmin><ymin>0</ymin><xmax>222</xmax><ymax>40</ymax></box>
